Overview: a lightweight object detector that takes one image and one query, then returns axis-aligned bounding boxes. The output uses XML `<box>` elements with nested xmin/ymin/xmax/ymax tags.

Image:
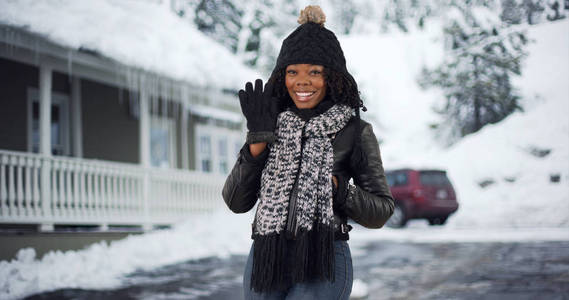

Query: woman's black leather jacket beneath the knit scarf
<box><xmin>222</xmin><ymin>118</ymin><xmax>394</xmax><ymax>239</ymax></box>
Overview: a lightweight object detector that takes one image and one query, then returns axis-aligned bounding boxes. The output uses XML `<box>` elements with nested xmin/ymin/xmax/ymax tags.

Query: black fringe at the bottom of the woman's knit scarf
<box><xmin>251</xmin><ymin>224</ymin><xmax>335</xmax><ymax>292</ymax></box>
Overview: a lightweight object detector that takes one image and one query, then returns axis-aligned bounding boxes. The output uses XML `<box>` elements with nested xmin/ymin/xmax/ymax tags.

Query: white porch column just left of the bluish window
<box><xmin>139</xmin><ymin>85</ymin><xmax>152</xmax><ymax>231</ymax></box>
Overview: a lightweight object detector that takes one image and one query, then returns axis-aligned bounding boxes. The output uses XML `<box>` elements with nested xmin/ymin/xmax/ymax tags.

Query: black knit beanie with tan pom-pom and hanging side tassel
<box><xmin>271</xmin><ymin>5</ymin><xmax>367</xmax><ymax>170</ymax></box>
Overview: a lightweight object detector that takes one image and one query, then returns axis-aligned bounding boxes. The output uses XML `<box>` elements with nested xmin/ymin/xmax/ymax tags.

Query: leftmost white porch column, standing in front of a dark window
<box><xmin>39</xmin><ymin>64</ymin><xmax>53</xmax><ymax>231</ymax></box>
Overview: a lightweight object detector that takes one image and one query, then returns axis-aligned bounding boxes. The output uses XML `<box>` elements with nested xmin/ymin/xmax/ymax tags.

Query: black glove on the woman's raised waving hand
<box><xmin>239</xmin><ymin>79</ymin><xmax>280</xmax><ymax>144</ymax></box>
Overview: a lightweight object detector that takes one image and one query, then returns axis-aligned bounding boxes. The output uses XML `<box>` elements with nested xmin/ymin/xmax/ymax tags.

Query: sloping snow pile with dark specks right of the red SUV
<box><xmin>432</xmin><ymin>94</ymin><xmax>569</xmax><ymax>227</ymax></box>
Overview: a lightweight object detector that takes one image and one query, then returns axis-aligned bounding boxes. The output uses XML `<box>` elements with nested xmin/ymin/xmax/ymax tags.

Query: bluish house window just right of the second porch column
<box><xmin>150</xmin><ymin>116</ymin><xmax>176</xmax><ymax>168</ymax></box>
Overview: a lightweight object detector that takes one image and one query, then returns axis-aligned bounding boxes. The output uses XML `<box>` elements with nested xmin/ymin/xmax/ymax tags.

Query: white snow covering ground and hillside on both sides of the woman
<box><xmin>0</xmin><ymin>10</ymin><xmax>569</xmax><ymax>299</ymax></box>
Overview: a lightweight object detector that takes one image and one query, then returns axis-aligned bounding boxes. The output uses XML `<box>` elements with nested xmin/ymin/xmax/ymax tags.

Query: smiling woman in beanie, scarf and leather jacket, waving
<box><xmin>223</xmin><ymin>6</ymin><xmax>393</xmax><ymax>299</ymax></box>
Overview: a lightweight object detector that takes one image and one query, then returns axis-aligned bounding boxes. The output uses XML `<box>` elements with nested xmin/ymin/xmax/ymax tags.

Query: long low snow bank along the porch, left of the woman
<box><xmin>0</xmin><ymin>211</ymin><xmax>253</xmax><ymax>299</ymax></box>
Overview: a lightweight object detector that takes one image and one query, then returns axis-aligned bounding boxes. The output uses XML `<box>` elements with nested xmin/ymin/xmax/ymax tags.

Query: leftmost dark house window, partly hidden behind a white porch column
<box><xmin>28</xmin><ymin>88</ymin><xmax>70</xmax><ymax>155</ymax></box>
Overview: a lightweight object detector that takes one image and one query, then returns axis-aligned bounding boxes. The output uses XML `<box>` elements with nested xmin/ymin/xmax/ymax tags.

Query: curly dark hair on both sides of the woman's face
<box><xmin>269</xmin><ymin>68</ymin><xmax>367</xmax><ymax>111</ymax></box>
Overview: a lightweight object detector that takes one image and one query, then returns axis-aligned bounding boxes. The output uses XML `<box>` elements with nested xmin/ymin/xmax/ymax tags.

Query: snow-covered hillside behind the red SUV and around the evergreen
<box><xmin>342</xmin><ymin>20</ymin><xmax>569</xmax><ymax>228</ymax></box>
